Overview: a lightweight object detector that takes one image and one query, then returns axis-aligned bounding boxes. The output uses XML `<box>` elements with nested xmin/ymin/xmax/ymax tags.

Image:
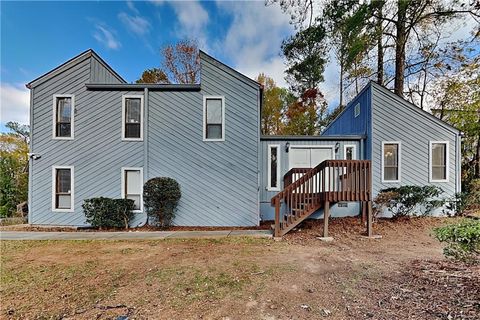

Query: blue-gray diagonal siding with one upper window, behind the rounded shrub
<box><xmin>148</xmin><ymin>58</ymin><xmax>259</xmax><ymax>226</ymax></box>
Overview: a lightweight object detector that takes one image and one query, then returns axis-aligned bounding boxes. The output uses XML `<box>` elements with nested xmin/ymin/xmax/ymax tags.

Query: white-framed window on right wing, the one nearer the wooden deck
<box><xmin>382</xmin><ymin>141</ymin><xmax>402</xmax><ymax>182</ymax></box>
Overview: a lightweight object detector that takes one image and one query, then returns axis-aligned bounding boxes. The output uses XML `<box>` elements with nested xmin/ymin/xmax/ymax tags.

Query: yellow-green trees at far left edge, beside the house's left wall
<box><xmin>0</xmin><ymin>122</ymin><xmax>29</xmax><ymax>216</ymax></box>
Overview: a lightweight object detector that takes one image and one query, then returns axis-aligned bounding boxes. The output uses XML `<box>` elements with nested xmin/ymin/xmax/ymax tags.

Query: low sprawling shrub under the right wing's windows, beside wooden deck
<box><xmin>373</xmin><ymin>185</ymin><xmax>444</xmax><ymax>218</ymax></box>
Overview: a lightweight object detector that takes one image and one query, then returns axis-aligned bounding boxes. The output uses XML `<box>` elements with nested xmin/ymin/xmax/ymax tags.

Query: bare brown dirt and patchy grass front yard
<box><xmin>0</xmin><ymin>218</ymin><xmax>480</xmax><ymax>319</ymax></box>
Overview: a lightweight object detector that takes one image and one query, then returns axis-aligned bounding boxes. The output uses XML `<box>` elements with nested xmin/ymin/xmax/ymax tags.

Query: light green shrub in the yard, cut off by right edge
<box><xmin>433</xmin><ymin>219</ymin><xmax>480</xmax><ymax>263</ymax></box>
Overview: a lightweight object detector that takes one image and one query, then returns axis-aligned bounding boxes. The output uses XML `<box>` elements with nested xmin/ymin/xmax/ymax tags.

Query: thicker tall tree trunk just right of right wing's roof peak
<box><xmin>394</xmin><ymin>0</ymin><xmax>408</xmax><ymax>97</ymax></box>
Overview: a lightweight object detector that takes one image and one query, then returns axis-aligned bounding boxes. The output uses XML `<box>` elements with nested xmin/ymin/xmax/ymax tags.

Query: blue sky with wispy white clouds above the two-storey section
<box><xmin>0</xmin><ymin>1</ymin><xmax>293</xmax><ymax>130</ymax></box>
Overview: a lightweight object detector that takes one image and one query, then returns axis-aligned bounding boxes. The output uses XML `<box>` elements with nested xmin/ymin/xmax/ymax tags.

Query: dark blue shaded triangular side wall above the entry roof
<box><xmin>322</xmin><ymin>83</ymin><xmax>372</xmax><ymax>159</ymax></box>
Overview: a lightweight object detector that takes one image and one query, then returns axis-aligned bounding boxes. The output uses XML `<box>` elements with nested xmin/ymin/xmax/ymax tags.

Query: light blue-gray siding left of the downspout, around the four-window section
<box><xmin>30</xmin><ymin>55</ymin><xmax>143</xmax><ymax>225</ymax></box>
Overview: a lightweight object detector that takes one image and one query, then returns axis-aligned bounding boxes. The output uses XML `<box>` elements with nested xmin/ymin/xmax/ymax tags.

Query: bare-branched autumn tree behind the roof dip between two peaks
<box><xmin>136</xmin><ymin>40</ymin><xmax>200</xmax><ymax>84</ymax></box>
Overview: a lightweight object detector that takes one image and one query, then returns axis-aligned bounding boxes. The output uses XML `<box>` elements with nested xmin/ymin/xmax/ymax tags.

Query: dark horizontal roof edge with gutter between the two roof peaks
<box><xmin>85</xmin><ymin>83</ymin><xmax>201</xmax><ymax>91</ymax></box>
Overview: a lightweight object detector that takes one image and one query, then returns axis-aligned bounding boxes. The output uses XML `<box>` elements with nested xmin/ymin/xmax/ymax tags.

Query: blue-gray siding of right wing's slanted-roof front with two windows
<box><xmin>372</xmin><ymin>84</ymin><xmax>460</xmax><ymax>196</ymax></box>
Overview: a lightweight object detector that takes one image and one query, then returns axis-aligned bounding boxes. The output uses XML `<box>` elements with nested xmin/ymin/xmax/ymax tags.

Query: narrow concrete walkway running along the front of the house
<box><xmin>0</xmin><ymin>230</ymin><xmax>272</xmax><ymax>240</ymax></box>
